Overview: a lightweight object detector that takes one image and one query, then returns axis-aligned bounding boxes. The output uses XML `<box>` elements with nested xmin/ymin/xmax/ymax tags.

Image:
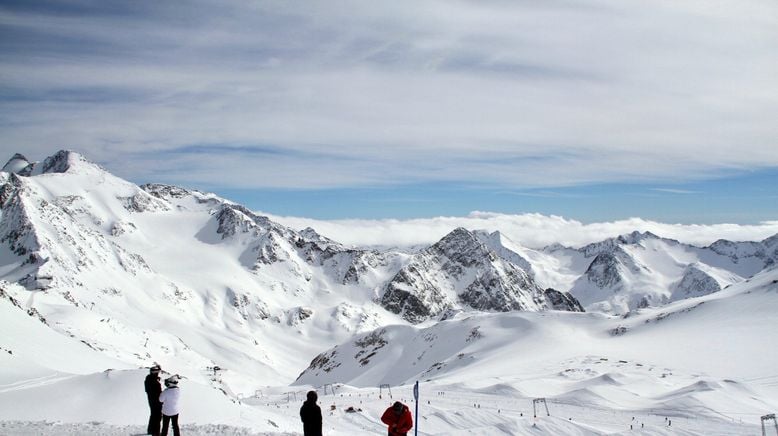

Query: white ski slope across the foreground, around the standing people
<box><xmin>0</xmin><ymin>270</ymin><xmax>778</xmax><ymax>435</ymax></box>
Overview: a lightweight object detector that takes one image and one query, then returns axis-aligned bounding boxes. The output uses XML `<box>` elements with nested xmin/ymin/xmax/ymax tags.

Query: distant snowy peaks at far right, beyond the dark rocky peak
<box><xmin>543</xmin><ymin>232</ymin><xmax>778</xmax><ymax>314</ymax></box>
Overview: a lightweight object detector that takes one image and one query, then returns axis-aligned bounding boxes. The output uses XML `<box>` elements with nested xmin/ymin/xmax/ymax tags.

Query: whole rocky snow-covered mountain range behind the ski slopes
<box><xmin>0</xmin><ymin>150</ymin><xmax>778</xmax><ymax>384</ymax></box>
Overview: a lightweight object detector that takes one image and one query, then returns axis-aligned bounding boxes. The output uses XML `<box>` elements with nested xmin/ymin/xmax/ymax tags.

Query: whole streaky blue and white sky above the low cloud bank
<box><xmin>0</xmin><ymin>0</ymin><xmax>778</xmax><ymax>224</ymax></box>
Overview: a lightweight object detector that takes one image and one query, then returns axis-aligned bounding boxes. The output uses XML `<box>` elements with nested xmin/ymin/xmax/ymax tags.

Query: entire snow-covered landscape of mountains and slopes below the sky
<box><xmin>0</xmin><ymin>150</ymin><xmax>778</xmax><ymax>435</ymax></box>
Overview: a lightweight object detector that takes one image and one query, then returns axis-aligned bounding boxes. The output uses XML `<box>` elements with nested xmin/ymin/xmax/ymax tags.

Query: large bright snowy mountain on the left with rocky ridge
<box><xmin>0</xmin><ymin>152</ymin><xmax>402</xmax><ymax>389</ymax></box>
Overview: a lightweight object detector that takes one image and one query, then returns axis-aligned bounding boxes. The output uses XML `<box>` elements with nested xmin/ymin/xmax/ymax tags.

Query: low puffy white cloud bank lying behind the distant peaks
<box><xmin>271</xmin><ymin>212</ymin><xmax>778</xmax><ymax>249</ymax></box>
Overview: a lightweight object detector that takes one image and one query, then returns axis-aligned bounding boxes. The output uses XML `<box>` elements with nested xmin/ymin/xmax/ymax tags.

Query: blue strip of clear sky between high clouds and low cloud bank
<box><xmin>217</xmin><ymin>170</ymin><xmax>778</xmax><ymax>224</ymax></box>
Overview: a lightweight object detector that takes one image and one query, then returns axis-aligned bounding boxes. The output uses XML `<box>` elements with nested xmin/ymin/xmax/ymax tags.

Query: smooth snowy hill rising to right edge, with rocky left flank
<box><xmin>296</xmin><ymin>269</ymin><xmax>778</xmax><ymax>434</ymax></box>
